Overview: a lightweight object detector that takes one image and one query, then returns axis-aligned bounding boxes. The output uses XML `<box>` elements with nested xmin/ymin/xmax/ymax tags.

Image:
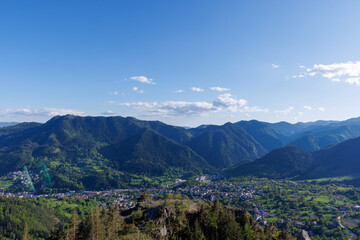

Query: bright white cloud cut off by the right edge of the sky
<box><xmin>294</xmin><ymin>61</ymin><xmax>360</xmax><ymax>86</ymax></box>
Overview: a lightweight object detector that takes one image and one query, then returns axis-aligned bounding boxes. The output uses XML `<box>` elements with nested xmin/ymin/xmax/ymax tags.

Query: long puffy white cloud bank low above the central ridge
<box><xmin>119</xmin><ymin>94</ymin><xmax>269</xmax><ymax>117</ymax></box>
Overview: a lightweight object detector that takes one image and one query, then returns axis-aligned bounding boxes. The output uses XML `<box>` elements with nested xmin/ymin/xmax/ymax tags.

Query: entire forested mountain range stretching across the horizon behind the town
<box><xmin>0</xmin><ymin>115</ymin><xmax>360</xmax><ymax>189</ymax></box>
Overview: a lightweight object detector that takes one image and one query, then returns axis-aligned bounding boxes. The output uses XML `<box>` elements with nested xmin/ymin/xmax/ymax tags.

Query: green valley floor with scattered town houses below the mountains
<box><xmin>0</xmin><ymin>176</ymin><xmax>360</xmax><ymax>239</ymax></box>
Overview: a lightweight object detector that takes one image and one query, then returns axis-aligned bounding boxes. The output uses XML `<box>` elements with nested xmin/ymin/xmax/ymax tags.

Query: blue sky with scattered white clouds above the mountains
<box><xmin>0</xmin><ymin>0</ymin><xmax>360</xmax><ymax>127</ymax></box>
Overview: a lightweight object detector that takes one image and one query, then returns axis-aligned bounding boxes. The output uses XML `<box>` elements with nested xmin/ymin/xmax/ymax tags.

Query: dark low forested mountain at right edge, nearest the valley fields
<box><xmin>226</xmin><ymin>137</ymin><xmax>360</xmax><ymax>179</ymax></box>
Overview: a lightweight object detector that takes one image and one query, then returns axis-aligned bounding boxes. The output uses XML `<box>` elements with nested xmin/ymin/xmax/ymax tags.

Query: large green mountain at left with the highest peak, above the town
<box><xmin>0</xmin><ymin>115</ymin><xmax>211</xmax><ymax>189</ymax></box>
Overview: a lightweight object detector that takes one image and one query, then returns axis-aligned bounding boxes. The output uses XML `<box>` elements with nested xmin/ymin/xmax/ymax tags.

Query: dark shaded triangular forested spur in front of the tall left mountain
<box><xmin>103</xmin><ymin>129</ymin><xmax>209</xmax><ymax>175</ymax></box>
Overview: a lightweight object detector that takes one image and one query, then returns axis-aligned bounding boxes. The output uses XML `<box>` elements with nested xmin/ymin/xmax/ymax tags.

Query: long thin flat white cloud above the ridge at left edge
<box><xmin>0</xmin><ymin>107</ymin><xmax>85</xmax><ymax>118</ymax></box>
